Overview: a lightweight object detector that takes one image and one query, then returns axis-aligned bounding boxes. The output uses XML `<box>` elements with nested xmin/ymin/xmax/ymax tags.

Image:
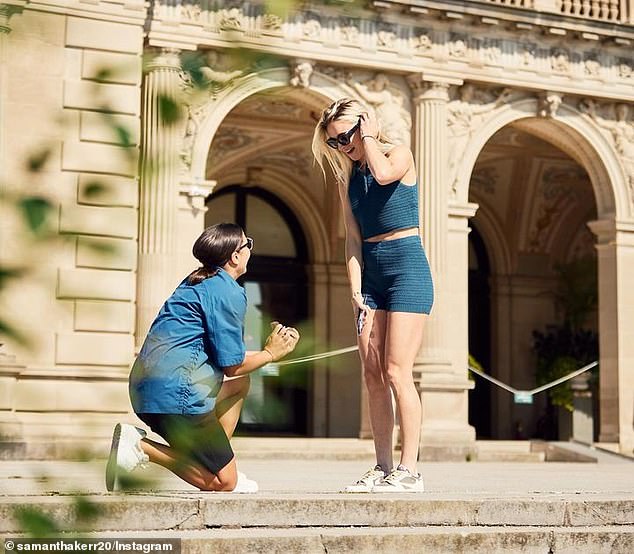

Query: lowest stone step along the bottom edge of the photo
<box><xmin>78</xmin><ymin>526</ymin><xmax>634</xmax><ymax>554</ymax></box>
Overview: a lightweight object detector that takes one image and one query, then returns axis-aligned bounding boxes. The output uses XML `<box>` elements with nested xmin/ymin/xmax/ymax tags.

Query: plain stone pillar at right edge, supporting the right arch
<box><xmin>588</xmin><ymin>219</ymin><xmax>634</xmax><ymax>456</ymax></box>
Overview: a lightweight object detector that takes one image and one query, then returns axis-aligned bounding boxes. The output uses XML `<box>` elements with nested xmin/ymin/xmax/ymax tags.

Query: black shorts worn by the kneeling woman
<box><xmin>137</xmin><ymin>412</ymin><xmax>234</xmax><ymax>475</ymax></box>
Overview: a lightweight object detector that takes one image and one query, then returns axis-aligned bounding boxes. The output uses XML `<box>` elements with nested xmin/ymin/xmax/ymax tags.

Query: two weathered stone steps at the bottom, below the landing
<box><xmin>0</xmin><ymin>491</ymin><xmax>634</xmax><ymax>554</ymax></box>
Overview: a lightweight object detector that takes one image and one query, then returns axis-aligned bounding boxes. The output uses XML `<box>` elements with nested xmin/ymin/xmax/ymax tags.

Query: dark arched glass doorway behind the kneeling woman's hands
<box><xmin>206</xmin><ymin>185</ymin><xmax>310</xmax><ymax>435</ymax></box>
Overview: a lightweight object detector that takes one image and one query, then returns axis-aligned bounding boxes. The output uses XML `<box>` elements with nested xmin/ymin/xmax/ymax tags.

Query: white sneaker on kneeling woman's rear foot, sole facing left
<box><xmin>106</xmin><ymin>423</ymin><xmax>150</xmax><ymax>492</ymax></box>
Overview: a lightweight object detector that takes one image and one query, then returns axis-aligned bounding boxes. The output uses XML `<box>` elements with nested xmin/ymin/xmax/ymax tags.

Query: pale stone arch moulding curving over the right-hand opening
<box><xmin>456</xmin><ymin>98</ymin><xmax>630</xmax><ymax>219</ymax></box>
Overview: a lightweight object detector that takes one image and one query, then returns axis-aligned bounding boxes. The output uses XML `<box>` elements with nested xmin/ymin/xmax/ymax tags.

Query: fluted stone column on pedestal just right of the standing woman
<box><xmin>408</xmin><ymin>74</ymin><xmax>475</xmax><ymax>460</ymax></box>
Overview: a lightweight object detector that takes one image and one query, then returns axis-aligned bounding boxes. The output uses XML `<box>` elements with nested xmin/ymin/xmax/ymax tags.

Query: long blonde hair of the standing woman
<box><xmin>312</xmin><ymin>98</ymin><xmax>394</xmax><ymax>185</ymax></box>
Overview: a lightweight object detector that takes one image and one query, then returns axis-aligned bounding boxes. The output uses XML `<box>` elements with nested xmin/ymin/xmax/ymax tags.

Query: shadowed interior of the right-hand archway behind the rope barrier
<box><xmin>469</xmin><ymin>123</ymin><xmax>598</xmax><ymax>439</ymax></box>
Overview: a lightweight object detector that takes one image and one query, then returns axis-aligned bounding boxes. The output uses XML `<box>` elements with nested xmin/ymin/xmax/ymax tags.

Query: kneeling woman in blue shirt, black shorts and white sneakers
<box><xmin>106</xmin><ymin>223</ymin><xmax>299</xmax><ymax>492</ymax></box>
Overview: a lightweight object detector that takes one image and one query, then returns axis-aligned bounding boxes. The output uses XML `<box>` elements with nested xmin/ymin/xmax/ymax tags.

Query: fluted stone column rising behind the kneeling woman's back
<box><xmin>136</xmin><ymin>49</ymin><xmax>181</xmax><ymax>349</ymax></box>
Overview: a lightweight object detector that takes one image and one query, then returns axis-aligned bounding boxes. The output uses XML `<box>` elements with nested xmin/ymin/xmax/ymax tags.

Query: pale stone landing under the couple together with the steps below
<box><xmin>0</xmin><ymin>439</ymin><xmax>634</xmax><ymax>554</ymax></box>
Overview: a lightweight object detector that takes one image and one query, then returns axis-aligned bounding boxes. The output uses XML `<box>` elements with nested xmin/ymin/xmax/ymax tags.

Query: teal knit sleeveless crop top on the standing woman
<box><xmin>348</xmin><ymin>163</ymin><xmax>418</xmax><ymax>240</ymax></box>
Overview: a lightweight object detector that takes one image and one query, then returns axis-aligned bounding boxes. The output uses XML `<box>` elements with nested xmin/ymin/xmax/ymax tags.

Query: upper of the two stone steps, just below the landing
<box><xmin>0</xmin><ymin>491</ymin><xmax>634</xmax><ymax>532</ymax></box>
